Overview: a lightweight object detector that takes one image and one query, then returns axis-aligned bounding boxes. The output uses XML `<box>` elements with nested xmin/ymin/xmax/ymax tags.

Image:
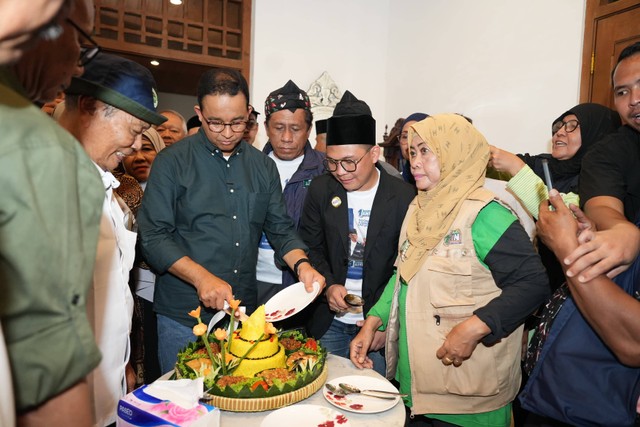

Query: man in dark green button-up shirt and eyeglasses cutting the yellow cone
<box><xmin>138</xmin><ymin>69</ymin><xmax>324</xmax><ymax>371</ymax></box>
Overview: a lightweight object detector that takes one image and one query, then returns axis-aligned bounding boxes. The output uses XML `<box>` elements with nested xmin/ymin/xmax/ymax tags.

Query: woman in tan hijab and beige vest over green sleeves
<box><xmin>351</xmin><ymin>114</ymin><xmax>548</xmax><ymax>427</ymax></box>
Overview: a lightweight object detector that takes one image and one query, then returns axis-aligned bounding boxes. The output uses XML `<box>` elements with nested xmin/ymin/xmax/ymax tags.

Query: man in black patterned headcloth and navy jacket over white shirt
<box><xmin>256</xmin><ymin>80</ymin><xmax>324</xmax><ymax>305</ymax></box>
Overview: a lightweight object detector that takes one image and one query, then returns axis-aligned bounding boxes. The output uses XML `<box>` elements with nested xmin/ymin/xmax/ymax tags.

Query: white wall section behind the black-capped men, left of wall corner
<box><xmin>251</xmin><ymin>0</ymin><xmax>390</xmax><ymax>150</ymax></box>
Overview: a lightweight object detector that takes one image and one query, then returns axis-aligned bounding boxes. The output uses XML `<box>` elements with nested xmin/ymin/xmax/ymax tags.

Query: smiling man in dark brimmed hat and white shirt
<box><xmin>59</xmin><ymin>53</ymin><xmax>166</xmax><ymax>426</ymax></box>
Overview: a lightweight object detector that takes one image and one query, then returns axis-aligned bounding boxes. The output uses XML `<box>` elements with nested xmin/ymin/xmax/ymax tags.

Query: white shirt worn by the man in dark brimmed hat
<box><xmin>87</xmin><ymin>165</ymin><xmax>136</xmax><ymax>427</ymax></box>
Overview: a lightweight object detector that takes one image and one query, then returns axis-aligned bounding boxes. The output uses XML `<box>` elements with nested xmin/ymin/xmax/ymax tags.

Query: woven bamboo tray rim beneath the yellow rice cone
<box><xmin>202</xmin><ymin>361</ymin><xmax>328</xmax><ymax>412</ymax></box>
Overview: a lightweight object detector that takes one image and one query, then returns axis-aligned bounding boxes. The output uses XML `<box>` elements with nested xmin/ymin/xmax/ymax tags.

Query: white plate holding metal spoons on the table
<box><xmin>322</xmin><ymin>375</ymin><xmax>400</xmax><ymax>414</ymax></box>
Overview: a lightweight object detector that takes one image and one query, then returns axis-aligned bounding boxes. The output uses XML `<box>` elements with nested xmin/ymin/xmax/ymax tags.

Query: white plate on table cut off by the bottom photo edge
<box><xmin>260</xmin><ymin>405</ymin><xmax>351</xmax><ymax>427</ymax></box>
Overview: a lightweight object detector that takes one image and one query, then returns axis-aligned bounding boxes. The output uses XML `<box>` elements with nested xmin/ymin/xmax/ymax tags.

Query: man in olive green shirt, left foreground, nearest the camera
<box><xmin>0</xmin><ymin>0</ymin><xmax>104</xmax><ymax>426</ymax></box>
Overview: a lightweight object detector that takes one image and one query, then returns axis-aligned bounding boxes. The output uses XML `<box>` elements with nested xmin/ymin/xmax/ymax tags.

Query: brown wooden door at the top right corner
<box><xmin>580</xmin><ymin>0</ymin><xmax>640</xmax><ymax>108</ymax></box>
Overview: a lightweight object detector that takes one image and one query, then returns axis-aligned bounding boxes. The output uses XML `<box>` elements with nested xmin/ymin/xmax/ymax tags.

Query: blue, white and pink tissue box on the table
<box><xmin>116</xmin><ymin>385</ymin><xmax>220</xmax><ymax>427</ymax></box>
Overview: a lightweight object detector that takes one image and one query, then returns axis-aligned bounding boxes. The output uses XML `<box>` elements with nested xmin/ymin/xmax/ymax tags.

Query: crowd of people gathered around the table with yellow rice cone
<box><xmin>0</xmin><ymin>0</ymin><xmax>640</xmax><ymax>427</ymax></box>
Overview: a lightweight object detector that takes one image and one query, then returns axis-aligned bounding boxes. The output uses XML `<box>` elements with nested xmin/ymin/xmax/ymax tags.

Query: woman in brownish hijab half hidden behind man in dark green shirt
<box><xmin>116</xmin><ymin>128</ymin><xmax>165</xmax><ymax>386</ymax></box>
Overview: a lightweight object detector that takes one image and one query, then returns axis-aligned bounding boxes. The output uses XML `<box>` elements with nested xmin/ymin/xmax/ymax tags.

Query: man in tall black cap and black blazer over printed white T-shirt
<box><xmin>300</xmin><ymin>91</ymin><xmax>415</xmax><ymax>374</ymax></box>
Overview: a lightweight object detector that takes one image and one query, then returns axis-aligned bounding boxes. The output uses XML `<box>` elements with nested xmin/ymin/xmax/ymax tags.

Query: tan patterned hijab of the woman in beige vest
<box><xmin>398</xmin><ymin>114</ymin><xmax>489</xmax><ymax>283</ymax></box>
